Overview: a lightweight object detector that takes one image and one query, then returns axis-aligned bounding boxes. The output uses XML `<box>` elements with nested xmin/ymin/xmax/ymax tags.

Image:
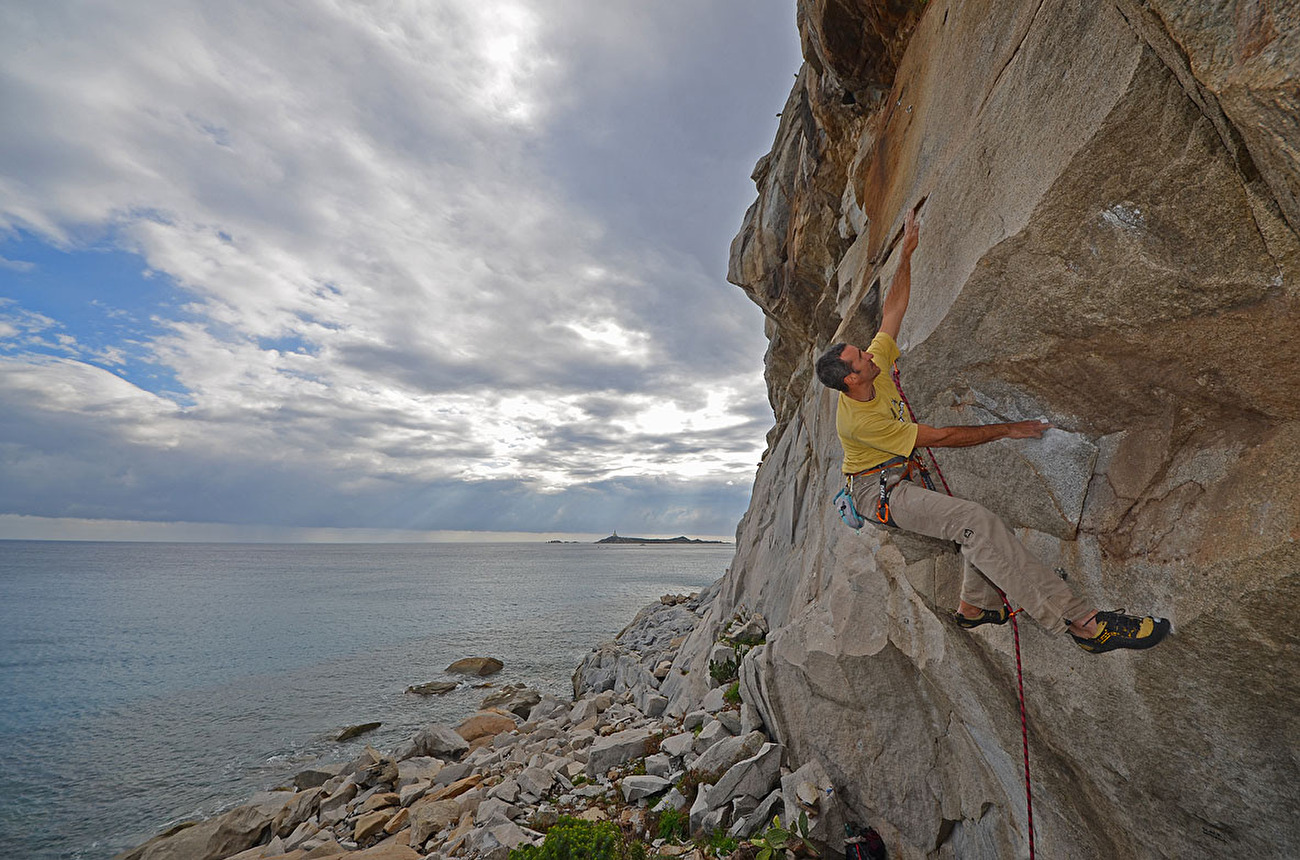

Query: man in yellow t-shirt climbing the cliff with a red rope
<box><xmin>816</xmin><ymin>212</ymin><xmax>1169</xmax><ymax>653</ymax></box>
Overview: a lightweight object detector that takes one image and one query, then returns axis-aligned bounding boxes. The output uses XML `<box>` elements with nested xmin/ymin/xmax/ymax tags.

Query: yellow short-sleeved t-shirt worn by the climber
<box><xmin>835</xmin><ymin>331</ymin><xmax>917</xmax><ymax>474</ymax></box>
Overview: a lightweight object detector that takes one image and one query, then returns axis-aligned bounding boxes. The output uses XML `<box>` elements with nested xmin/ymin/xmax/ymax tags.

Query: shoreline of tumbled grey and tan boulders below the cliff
<box><xmin>117</xmin><ymin>583</ymin><xmax>842</xmax><ymax>860</ymax></box>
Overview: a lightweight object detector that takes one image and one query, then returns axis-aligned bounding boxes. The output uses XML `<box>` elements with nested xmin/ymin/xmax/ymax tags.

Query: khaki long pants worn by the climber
<box><xmin>853</xmin><ymin>481</ymin><xmax>1092</xmax><ymax>634</ymax></box>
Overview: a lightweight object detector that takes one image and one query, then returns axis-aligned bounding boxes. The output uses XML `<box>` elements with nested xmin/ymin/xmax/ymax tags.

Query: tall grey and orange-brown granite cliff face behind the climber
<box><xmin>722</xmin><ymin>0</ymin><xmax>1300</xmax><ymax>860</ymax></box>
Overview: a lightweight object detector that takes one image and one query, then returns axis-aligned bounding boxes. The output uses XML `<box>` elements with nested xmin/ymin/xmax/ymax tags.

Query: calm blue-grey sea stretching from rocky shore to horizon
<box><xmin>0</xmin><ymin>540</ymin><xmax>735</xmax><ymax>860</ymax></box>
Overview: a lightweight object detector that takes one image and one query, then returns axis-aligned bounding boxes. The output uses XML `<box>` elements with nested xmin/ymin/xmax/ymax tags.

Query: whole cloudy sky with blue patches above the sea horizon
<box><xmin>0</xmin><ymin>0</ymin><xmax>800</xmax><ymax>538</ymax></box>
